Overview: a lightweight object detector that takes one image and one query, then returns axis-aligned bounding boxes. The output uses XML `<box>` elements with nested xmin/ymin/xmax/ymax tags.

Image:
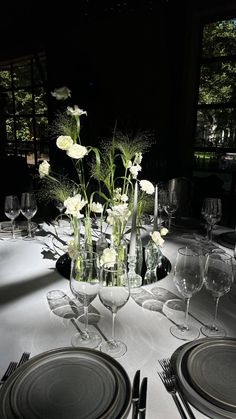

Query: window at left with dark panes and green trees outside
<box><xmin>0</xmin><ymin>53</ymin><xmax>48</xmax><ymax>165</ymax></box>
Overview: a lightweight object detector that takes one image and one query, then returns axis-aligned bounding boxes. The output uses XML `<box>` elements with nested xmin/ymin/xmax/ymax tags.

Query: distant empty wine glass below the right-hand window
<box><xmin>201</xmin><ymin>198</ymin><xmax>222</xmax><ymax>241</ymax></box>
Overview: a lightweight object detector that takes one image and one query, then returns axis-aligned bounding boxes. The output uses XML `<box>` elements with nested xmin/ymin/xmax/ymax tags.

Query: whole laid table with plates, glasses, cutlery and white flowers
<box><xmin>0</xmin><ymin>87</ymin><xmax>236</xmax><ymax>419</ymax></box>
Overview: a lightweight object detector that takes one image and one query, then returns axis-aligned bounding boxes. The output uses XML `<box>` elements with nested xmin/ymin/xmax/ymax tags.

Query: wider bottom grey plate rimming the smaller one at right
<box><xmin>171</xmin><ymin>338</ymin><xmax>236</xmax><ymax>419</ymax></box>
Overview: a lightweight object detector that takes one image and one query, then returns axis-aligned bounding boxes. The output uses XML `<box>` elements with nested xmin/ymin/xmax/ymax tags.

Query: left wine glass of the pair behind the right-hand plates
<box><xmin>170</xmin><ymin>246</ymin><xmax>204</xmax><ymax>340</ymax></box>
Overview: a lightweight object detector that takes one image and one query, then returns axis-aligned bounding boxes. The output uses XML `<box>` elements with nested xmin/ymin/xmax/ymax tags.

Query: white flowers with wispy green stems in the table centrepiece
<box><xmin>39</xmin><ymin>87</ymin><xmax>167</xmax><ymax>282</ymax></box>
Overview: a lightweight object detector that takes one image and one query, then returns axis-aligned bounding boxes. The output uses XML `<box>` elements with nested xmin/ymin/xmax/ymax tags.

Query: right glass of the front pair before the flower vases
<box><xmin>98</xmin><ymin>256</ymin><xmax>130</xmax><ymax>358</ymax></box>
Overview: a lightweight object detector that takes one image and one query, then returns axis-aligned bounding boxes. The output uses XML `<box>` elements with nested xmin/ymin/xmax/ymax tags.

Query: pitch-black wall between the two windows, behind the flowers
<box><xmin>0</xmin><ymin>0</ymin><xmax>236</xmax><ymax>180</ymax></box>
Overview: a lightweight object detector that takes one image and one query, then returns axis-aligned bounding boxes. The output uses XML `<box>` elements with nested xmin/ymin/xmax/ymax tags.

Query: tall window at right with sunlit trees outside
<box><xmin>195</xmin><ymin>18</ymin><xmax>236</xmax><ymax>169</ymax></box>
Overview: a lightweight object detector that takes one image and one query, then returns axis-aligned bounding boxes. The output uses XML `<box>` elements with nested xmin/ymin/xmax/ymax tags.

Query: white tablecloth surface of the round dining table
<box><xmin>0</xmin><ymin>223</ymin><xmax>236</xmax><ymax>419</ymax></box>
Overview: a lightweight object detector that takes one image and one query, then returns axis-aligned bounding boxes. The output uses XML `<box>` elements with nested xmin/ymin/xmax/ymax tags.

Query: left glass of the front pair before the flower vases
<box><xmin>70</xmin><ymin>250</ymin><xmax>102</xmax><ymax>348</ymax></box>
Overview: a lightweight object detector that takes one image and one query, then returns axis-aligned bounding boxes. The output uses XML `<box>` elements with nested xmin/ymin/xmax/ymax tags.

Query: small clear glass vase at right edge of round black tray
<box><xmin>143</xmin><ymin>240</ymin><xmax>162</xmax><ymax>285</ymax></box>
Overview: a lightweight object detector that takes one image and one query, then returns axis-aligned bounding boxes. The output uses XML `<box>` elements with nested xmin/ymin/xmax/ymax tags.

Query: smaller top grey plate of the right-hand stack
<box><xmin>187</xmin><ymin>339</ymin><xmax>236</xmax><ymax>413</ymax></box>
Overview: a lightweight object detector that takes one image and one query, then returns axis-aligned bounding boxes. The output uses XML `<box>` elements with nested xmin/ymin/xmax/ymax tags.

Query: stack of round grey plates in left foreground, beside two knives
<box><xmin>0</xmin><ymin>348</ymin><xmax>131</xmax><ymax>419</ymax></box>
